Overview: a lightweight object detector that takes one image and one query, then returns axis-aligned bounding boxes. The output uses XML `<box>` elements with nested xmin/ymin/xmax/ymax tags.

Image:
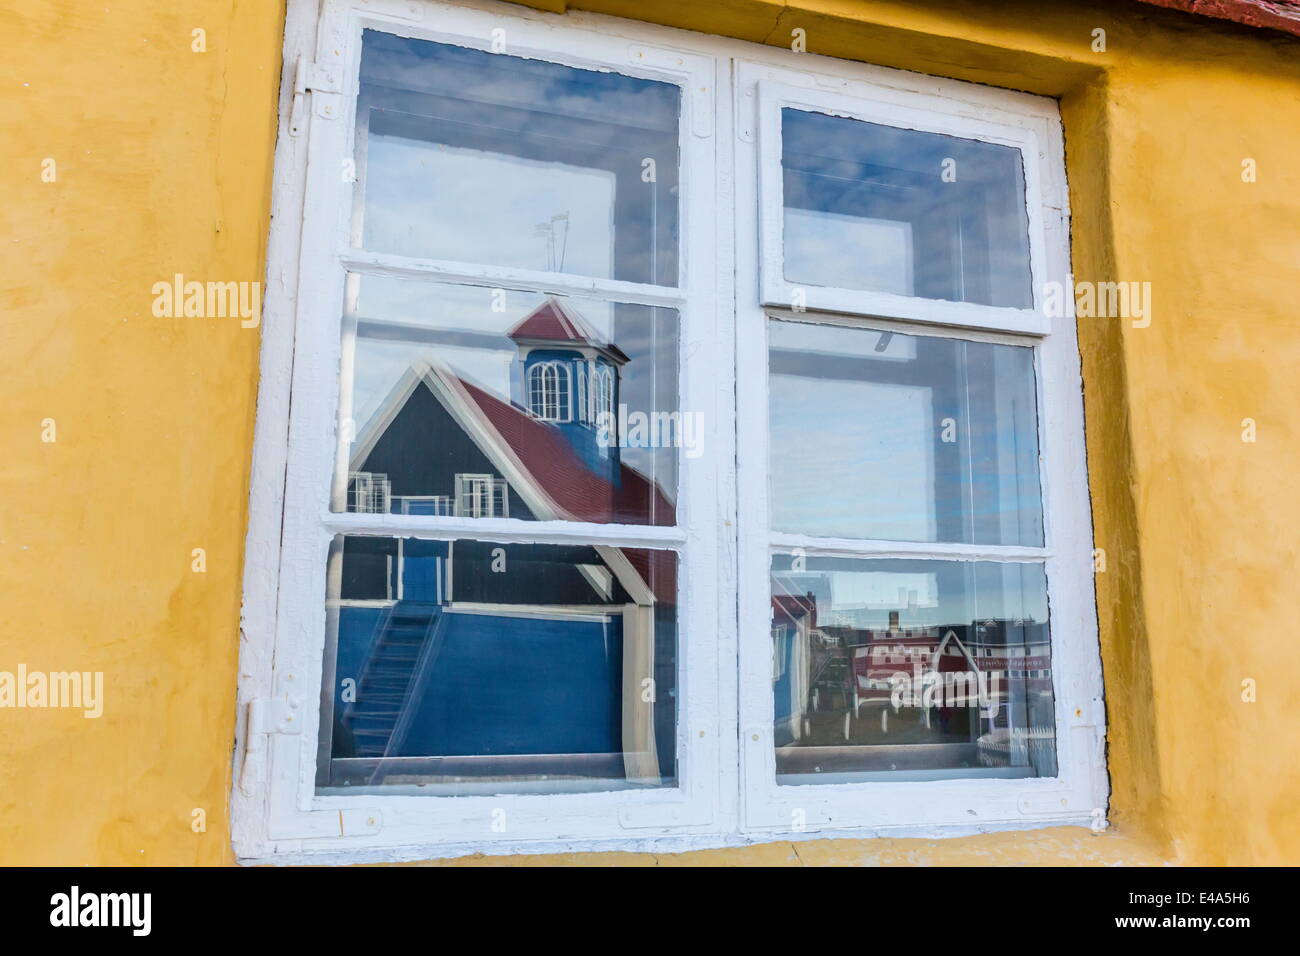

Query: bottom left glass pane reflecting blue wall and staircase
<box><xmin>317</xmin><ymin>536</ymin><xmax>677</xmax><ymax>793</ymax></box>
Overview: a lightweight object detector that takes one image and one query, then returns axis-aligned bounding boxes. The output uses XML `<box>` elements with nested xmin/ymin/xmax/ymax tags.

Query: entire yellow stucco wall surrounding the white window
<box><xmin>0</xmin><ymin>0</ymin><xmax>1300</xmax><ymax>865</ymax></box>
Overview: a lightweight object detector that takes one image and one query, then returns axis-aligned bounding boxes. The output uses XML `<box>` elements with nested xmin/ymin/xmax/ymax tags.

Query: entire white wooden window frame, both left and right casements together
<box><xmin>231</xmin><ymin>0</ymin><xmax>1106</xmax><ymax>862</ymax></box>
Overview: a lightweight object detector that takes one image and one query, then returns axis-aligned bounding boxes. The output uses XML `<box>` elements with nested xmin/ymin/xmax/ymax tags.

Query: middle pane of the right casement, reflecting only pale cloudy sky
<box><xmin>768</xmin><ymin>320</ymin><xmax>1043</xmax><ymax>546</ymax></box>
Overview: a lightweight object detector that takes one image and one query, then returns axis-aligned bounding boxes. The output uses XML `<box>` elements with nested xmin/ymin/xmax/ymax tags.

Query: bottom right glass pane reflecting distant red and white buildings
<box><xmin>772</xmin><ymin>554</ymin><xmax>1056</xmax><ymax>784</ymax></box>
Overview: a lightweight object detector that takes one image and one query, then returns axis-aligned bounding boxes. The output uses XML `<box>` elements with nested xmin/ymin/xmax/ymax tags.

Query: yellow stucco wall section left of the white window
<box><xmin>0</xmin><ymin>0</ymin><xmax>283</xmax><ymax>864</ymax></box>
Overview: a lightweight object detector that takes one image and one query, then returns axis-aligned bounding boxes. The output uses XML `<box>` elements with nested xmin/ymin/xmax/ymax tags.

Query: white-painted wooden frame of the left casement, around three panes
<box><xmin>231</xmin><ymin>0</ymin><xmax>735</xmax><ymax>861</ymax></box>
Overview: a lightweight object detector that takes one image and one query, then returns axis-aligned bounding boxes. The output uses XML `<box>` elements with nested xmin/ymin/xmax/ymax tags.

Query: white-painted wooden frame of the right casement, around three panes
<box><xmin>735</xmin><ymin>57</ymin><xmax>1109</xmax><ymax>835</ymax></box>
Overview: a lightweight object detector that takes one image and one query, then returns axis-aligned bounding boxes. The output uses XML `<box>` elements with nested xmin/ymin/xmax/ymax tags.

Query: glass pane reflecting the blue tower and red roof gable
<box><xmin>333</xmin><ymin>276</ymin><xmax>681</xmax><ymax>525</ymax></box>
